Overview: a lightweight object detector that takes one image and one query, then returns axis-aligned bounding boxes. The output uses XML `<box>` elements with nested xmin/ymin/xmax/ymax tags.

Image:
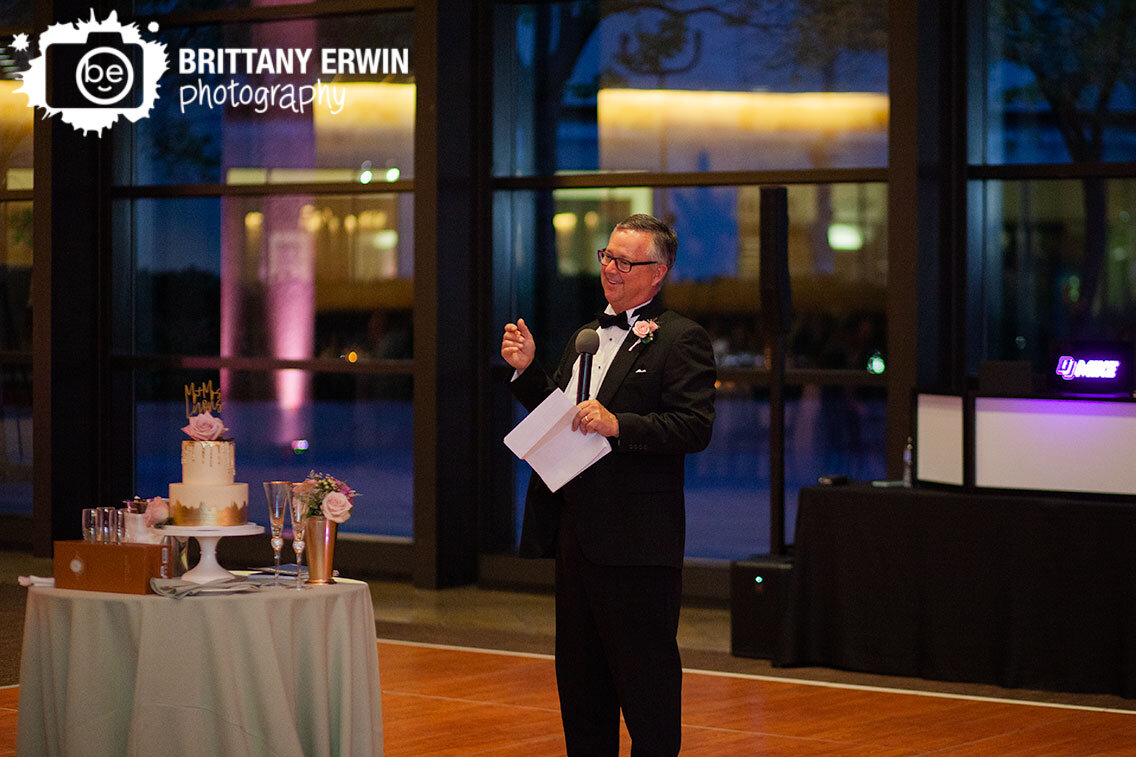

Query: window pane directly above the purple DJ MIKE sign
<box><xmin>968</xmin><ymin>177</ymin><xmax>1136</xmax><ymax>372</ymax></box>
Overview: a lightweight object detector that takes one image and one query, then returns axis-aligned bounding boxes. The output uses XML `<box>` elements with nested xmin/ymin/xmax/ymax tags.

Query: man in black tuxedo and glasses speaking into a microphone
<box><xmin>501</xmin><ymin>215</ymin><xmax>716</xmax><ymax>757</ymax></box>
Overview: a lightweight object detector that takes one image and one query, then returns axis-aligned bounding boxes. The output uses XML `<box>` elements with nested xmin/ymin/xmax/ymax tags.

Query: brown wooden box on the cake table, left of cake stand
<box><xmin>55</xmin><ymin>541</ymin><xmax>174</xmax><ymax>594</ymax></box>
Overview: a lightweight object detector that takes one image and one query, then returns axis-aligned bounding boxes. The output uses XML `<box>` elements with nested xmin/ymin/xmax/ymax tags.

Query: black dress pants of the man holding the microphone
<box><xmin>556</xmin><ymin>518</ymin><xmax>683</xmax><ymax>757</ymax></box>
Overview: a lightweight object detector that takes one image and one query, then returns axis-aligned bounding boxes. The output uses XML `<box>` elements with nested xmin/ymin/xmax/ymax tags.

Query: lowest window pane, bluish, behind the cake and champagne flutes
<box><xmin>134</xmin><ymin>371</ymin><xmax>414</xmax><ymax>538</ymax></box>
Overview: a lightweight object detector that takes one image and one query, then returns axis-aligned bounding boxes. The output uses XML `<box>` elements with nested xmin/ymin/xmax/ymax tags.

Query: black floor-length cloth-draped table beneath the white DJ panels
<box><xmin>775</xmin><ymin>484</ymin><xmax>1136</xmax><ymax>697</ymax></box>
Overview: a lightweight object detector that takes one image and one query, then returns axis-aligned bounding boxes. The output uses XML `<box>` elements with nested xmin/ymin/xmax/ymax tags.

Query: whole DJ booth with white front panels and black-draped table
<box><xmin>769</xmin><ymin>377</ymin><xmax>1136</xmax><ymax>697</ymax></box>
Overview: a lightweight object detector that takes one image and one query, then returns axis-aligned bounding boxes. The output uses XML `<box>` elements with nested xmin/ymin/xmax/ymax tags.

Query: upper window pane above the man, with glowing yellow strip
<box><xmin>493</xmin><ymin>0</ymin><xmax>888</xmax><ymax>176</ymax></box>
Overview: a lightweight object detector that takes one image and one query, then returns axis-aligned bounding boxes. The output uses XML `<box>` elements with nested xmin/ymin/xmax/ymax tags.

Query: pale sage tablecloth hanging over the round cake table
<box><xmin>16</xmin><ymin>580</ymin><xmax>383</xmax><ymax>757</ymax></box>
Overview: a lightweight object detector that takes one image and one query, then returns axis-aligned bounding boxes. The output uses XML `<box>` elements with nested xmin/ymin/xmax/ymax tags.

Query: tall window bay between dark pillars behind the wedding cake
<box><xmin>110</xmin><ymin>0</ymin><xmax>416</xmax><ymax>538</ymax></box>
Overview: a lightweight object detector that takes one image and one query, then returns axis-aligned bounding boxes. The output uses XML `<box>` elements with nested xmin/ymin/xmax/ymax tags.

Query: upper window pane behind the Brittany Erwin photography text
<box><xmin>115</xmin><ymin>13</ymin><xmax>416</xmax><ymax>186</ymax></box>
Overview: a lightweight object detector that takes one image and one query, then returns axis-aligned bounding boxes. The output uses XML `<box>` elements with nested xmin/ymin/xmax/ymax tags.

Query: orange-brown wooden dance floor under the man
<box><xmin>0</xmin><ymin>641</ymin><xmax>1136</xmax><ymax>757</ymax></box>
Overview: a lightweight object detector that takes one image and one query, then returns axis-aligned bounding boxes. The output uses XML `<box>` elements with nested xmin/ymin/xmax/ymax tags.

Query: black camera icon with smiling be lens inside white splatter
<box><xmin>45</xmin><ymin>32</ymin><xmax>144</xmax><ymax>108</ymax></box>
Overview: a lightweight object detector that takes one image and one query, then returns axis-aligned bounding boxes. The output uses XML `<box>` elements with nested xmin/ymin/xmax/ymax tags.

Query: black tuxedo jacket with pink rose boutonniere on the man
<box><xmin>510</xmin><ymin>298</ymin><xmax>717</xmax><ymax>567</ymax></box>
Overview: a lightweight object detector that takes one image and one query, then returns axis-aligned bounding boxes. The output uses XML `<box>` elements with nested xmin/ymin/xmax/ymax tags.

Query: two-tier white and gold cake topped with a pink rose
<box><xmin>169</xmin><ymin>413</ymin><xmax>249</xmax><ymax>526</ymax></box>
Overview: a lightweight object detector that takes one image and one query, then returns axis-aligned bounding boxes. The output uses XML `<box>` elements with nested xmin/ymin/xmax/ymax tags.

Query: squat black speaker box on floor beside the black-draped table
<box><xmin>729</xmin><ymin>555</ymin><xmax>793</xmax><ymax>659</ymax></box>
